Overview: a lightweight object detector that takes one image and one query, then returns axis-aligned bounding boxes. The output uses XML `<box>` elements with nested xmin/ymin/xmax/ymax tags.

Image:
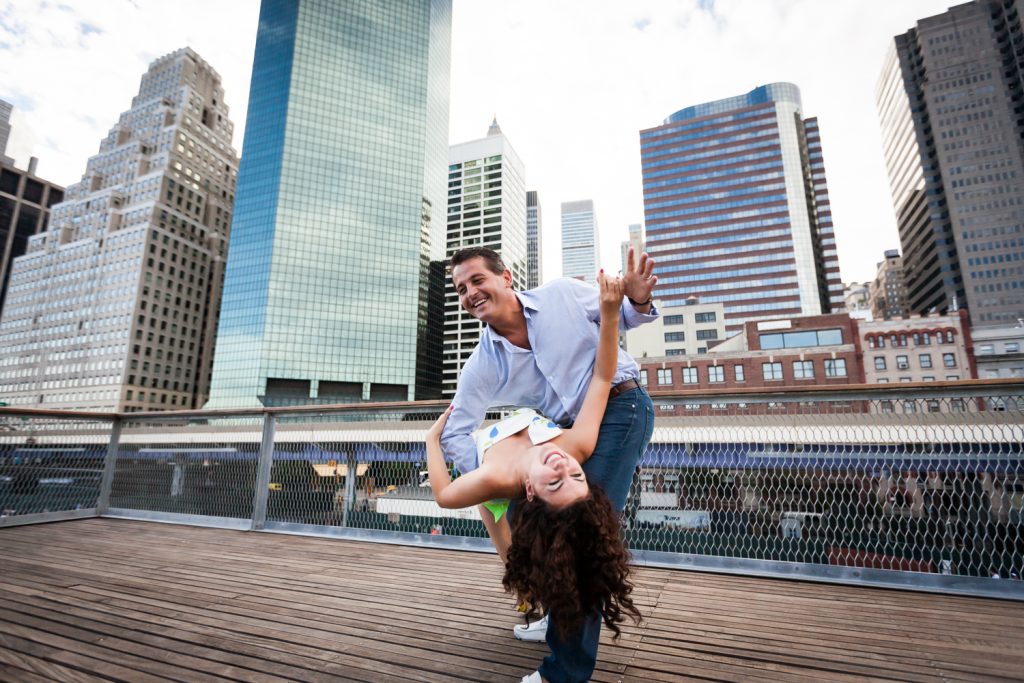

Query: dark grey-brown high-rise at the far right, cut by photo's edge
<box><xmin>876</xmin><ymin>0</ymin><xmax>1024</xmax><ymax>327</ymax></box>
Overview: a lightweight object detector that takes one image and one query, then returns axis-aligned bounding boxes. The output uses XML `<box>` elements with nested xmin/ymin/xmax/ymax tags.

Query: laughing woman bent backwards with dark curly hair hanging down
<box><xmin>427</xmin><ymin>271</ymin><xmax>639</xmax><ymax>636</ymax></box>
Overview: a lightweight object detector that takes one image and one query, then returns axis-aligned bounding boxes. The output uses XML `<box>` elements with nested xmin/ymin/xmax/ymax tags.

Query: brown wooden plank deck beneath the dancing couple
<box><xmin>0</xmin><ymin>519</ymin><xmax>1024</xmax><ymax>683</ymax></box>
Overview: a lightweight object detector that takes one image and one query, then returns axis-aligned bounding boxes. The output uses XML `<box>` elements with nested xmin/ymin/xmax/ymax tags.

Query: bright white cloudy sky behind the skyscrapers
<box><xmin>0</xmin><ymin>0</ymin><xmax>956</xmax><ymax>282</ymax></box>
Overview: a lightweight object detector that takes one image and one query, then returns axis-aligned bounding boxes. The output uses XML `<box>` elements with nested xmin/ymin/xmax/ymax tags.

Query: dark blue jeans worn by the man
<box><xmin>539</xmin><ymin>388</ymin><xmax>654</xmax><ymax>683</ymax></box>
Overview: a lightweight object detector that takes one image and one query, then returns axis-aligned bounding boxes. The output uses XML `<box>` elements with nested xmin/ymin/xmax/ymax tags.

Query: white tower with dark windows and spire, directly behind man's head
<box><xmin>442</xmin><ymin>121</ymin><xmax>537</xmax><ymax>396</ymax></box>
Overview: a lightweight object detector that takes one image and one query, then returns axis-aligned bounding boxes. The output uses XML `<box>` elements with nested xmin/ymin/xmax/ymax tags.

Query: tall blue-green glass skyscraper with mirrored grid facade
<box><xmin>208</xmin><ymin>0</ymin><xmax>452</xmax><ymax>408</ymax></box>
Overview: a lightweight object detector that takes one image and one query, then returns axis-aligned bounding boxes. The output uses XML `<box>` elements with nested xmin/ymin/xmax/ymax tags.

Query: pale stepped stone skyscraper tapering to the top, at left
<box><xmin>0</xmin><ymin>48</ymin><xmax>238</xmax><ymax>412</ymax></box>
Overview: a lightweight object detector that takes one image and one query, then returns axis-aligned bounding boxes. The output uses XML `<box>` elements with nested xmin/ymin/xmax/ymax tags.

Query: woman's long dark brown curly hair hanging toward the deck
<box><xmin>502</xmin><ymin>484</ymin><xmax>640</xmax><ymax>638</ymax></box>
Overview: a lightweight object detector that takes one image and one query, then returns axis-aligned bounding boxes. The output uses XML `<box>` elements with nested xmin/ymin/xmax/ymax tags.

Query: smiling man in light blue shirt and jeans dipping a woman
<box><xmin>441</xmin><ymin>247</ymin><xmax>658</xmax><ymax>683</ymax></box>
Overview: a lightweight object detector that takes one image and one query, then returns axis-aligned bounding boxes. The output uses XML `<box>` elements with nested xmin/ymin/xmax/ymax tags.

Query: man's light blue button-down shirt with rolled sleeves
<box><xmin>441</xmin><ymin>279</ymin><xmax>658</xmax><ymax>472</ymax></box>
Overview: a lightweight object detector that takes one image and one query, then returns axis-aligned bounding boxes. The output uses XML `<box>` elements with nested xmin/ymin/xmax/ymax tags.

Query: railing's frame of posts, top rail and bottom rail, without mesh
<box><xmin>0</xmin><ymin>379</ymin><xmax>1024</xmax><ymax>600</ymax></box>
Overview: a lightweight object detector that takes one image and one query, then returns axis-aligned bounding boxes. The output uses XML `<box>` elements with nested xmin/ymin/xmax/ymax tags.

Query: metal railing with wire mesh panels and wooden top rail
<box><xmin>0</xmin><ymin>381</ymin><xmax>1024</xmax><ymax>599</ymax></box>
